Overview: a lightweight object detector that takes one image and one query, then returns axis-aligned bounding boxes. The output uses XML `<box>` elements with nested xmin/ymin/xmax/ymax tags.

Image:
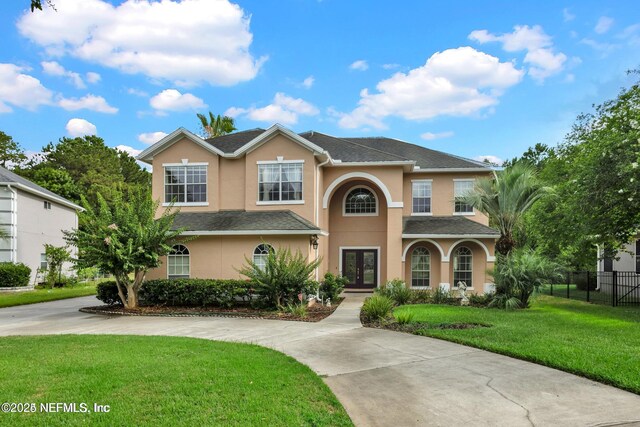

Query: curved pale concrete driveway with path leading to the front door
<box><xmin>0</xmin><ymin>295</ymin><xmax>640</xmax><ymax>427</ymax></box>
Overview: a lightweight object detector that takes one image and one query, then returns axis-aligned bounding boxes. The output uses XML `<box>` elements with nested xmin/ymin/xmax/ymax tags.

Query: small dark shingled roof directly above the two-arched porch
<box><xmin>402</xmin><ymin>216</ymin><xmax>500</xmax><ymax>238</ymax></box>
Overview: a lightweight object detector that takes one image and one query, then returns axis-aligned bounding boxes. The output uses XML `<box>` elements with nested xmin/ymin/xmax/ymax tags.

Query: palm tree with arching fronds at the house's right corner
<box><xmin>463</xmin><ymin>163</ymin><xmax>551</xmax><ymax>255</ymax></box>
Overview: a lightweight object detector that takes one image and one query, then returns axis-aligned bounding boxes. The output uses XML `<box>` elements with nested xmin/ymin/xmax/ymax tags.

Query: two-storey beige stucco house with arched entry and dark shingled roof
<box><xmin>138</xmin><ymin>125</ymin><xmax>499</xmax><ymax>292</ymax></box>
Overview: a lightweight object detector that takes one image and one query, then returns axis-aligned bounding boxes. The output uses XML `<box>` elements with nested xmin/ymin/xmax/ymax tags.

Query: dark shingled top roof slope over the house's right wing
<box><xmin>342</xmin><ymin>137</ymin><xmax>491</xmax><ymax>171</ymax></box>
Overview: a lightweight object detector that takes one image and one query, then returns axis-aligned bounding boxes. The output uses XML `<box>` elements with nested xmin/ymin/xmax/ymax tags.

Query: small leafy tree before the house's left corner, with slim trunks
<box><xmin>65</xmin><ymin>190</ymin><xmax>182</xmax><ymax>308</ymax></box>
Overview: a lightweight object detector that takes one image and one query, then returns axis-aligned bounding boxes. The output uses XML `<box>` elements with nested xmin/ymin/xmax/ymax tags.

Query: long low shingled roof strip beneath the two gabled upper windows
<box><xmin>173</xmin><ymin>210</ymin><xmax>322</xmax><ymax>236</ymax></box>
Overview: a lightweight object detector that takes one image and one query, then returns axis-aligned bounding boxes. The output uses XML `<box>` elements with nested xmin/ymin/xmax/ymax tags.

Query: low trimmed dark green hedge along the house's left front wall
<box><xmin>97</xmin><ymin>279</ymin><xmax>252</xmax><ymax>307</ymax></box>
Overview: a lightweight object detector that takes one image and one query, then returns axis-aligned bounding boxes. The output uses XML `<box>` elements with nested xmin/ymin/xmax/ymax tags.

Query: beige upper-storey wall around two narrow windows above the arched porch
<box><xmin>402</xmin><ymin>172</ymin><xmax>490</xmax><ymax>225</ymax></box>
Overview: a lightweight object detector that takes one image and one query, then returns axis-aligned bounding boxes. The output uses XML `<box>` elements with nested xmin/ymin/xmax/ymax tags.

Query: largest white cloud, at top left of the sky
<box><xmin>17</xmin><ymin>0</ymin><xmax>266</xmax><ymax>86</ymax></box>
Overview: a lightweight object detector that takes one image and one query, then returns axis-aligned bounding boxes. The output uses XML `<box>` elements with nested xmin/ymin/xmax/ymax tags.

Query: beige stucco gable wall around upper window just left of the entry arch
<box><xmin>245</xmin><ymin>134</ymin><xmax>316</xmax><ymax>222</ymax></box>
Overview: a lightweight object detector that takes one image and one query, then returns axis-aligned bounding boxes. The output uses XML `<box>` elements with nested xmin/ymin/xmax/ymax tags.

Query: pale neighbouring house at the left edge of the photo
<box><xmin>0</xmin><ymin>166</ymin><xmax>82</xmax><ymax>286</ymax></box>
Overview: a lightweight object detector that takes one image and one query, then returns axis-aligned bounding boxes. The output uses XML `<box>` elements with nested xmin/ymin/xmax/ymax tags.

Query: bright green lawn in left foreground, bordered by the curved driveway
<box><xmin>0</xmin><ymin>335</ymin><xmax>352</xmax><ymax>426</ymax></box>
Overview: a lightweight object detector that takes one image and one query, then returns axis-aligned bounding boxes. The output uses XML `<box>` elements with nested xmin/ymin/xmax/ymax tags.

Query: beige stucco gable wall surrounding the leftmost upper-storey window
<box><xmin>151</xmin><ymin>138</ymin><xmax>220</xmax><ymax>212</ymax></box>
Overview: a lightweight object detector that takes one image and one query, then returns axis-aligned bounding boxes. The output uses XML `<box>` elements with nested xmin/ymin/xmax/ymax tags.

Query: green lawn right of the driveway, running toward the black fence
<box><xmin>395</xmin><ymin>296</ymin><xmax>640</xmax><ymax>394</ymax></box>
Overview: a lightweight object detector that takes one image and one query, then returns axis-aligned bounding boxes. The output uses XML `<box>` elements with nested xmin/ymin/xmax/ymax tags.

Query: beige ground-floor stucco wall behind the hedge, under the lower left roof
<box><xmin>147</xmin><ymin>236</ymin><xmax>314</xmax><ymax>279</ymax></box>
